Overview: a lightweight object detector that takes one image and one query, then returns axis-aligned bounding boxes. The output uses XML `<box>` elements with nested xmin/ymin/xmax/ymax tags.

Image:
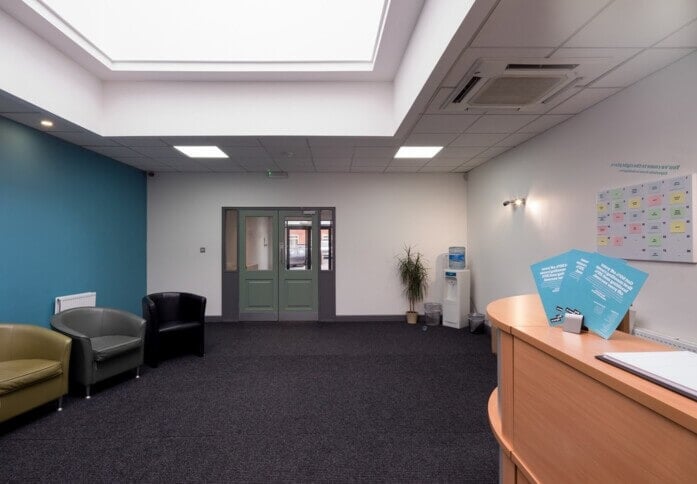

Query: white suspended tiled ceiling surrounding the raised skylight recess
<box><xmin>0</xmin><ymin>0</ymin><xmax>697</xmax><ymax>173</ymax></box>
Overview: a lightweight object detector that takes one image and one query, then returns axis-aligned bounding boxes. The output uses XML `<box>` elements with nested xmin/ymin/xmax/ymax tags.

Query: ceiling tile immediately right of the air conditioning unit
<box><xmin>593</xmin><ymin>49</ymin><xmax>694</xmax><ymax>87</ymax></box>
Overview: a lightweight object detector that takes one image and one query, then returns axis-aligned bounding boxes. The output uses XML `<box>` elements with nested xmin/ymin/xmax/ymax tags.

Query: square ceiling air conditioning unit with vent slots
<box><xmin>440</xmin><ymin>59</ymin><xmax>593</xmax><ymax>112</ymax></box>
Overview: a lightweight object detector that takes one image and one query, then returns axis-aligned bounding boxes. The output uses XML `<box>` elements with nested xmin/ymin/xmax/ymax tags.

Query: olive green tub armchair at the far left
<box><xmin>0</xmin><ymin>323</ymin><xmax>71</xmax><ymax>422</ymax></box>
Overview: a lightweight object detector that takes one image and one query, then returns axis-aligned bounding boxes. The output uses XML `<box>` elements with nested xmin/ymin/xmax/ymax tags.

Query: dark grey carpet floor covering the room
<box><xmin>0</xmin><ymin>322</ymin><xmax>498</xmax><ymax>483</ymax></box>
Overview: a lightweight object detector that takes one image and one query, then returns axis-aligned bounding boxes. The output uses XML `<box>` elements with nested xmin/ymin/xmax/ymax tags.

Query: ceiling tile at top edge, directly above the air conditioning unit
<box><xmin>472</xmin><ymin>0</ymin><xmax>607</xmax><ymax>47</ymax></box>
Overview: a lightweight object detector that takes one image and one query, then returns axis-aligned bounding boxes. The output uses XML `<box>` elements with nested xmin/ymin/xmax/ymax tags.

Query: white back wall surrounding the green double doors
<box><xmin>147</xmin><ymin>173</ymin><xmax>467</xmax><ymax>315</ymax></box>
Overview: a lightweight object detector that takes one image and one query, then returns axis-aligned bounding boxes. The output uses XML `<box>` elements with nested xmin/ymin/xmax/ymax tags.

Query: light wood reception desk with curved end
<box><xmin>487</xmin><ymin>294</ymin><xmax>697</xmax><ymax>483</ymax></box>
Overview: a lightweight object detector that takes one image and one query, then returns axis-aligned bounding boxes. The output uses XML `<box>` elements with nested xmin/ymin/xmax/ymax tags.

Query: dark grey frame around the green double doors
<box><xmin>220</xmin><ymin>206</ymin><xmax>337</xmax><ymax>322</ymax></box>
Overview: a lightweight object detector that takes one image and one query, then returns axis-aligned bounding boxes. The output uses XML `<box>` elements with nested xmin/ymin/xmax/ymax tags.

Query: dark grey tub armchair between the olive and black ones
<box><xmin>51</xmin><ymin>307</ymin><xmax>145</xmax><ymax>398</ymax></box>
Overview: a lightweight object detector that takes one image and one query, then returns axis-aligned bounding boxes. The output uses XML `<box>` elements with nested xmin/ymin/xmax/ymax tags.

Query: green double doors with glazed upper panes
<box><xmin>238</xmin><ymin>210</ymin><xmax>321</xmax><ymax>321</ymax></box>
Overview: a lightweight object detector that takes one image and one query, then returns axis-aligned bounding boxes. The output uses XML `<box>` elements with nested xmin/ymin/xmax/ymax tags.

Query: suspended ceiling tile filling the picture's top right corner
<box><xmin>564</xmin><ymin>0</ymin><xmax>697</xmax><ymax>47</ymax></box>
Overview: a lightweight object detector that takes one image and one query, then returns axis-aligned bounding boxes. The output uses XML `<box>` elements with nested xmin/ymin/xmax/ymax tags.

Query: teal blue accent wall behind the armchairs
<box><xmin>0</xmin><ymin>117</ymin><xmax>147</xmax><ymax>326</ymax></box>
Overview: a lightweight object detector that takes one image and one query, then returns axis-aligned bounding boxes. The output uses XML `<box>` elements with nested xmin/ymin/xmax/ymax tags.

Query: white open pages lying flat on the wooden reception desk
<box><xmin>596</xmin><ymin>351</ymin><xmax>697</xmax><ymax>401</ymax></box>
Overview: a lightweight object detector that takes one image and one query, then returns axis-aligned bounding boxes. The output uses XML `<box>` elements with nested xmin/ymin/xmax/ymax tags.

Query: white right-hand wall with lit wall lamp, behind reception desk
<box><xmin>467</xmin><ymin>54</ymin><xmax>697</xmax><ymax>341</ymax></box>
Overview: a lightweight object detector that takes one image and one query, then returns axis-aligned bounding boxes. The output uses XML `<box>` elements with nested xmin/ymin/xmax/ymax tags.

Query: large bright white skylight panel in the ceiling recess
<box><xmin>41</xmin><ymin>0</ymin><xmax>387</xmax><ymax>63</ymax></box>
